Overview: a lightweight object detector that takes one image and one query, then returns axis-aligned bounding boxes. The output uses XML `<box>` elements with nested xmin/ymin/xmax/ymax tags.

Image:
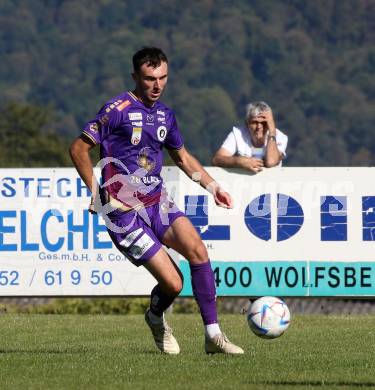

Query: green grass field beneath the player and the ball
<box><xmin>0</xmin><ymin>314</ymin><xmax>375</xmax><ymax>390</ymax></box>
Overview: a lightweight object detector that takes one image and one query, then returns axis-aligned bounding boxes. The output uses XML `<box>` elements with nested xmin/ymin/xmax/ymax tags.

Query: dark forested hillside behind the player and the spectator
<box><xmin>0</xmin><ymin>0</ymin><xmax>375</xmax><ymax>166</ymax></box>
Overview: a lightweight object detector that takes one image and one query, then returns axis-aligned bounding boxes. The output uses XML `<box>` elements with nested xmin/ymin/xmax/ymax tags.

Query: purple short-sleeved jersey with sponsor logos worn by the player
<box><xmin>83</xmin><ymin>92</ymin><xmax>183</xmax><ymax>208</ymax></box>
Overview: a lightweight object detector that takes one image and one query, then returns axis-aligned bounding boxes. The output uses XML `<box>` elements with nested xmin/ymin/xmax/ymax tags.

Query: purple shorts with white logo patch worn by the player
<box><xmin>107</xmin><ymin>199</ymin><xmax>185</xmax><ymax>267</ymax></box>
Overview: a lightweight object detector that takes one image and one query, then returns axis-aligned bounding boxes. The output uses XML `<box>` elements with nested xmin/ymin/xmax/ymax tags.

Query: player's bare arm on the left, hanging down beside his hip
<box><xmin>69</xmin><ymin>135</ymin><xmax>99</xmax><ymax>212</ymax></box>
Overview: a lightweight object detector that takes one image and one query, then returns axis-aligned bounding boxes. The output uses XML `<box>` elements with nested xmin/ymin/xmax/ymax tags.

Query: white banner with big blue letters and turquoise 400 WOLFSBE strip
<box><xmin>179</xmin><ymin>168</ymin><xmax>375</xmax><ymax>296</ymax></box>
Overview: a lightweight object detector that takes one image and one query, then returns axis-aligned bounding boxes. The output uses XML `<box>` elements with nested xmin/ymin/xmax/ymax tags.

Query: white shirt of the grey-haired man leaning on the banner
<box><xmin>221</xmin><ymin>126</ymin><xmax>288</xmax><ymax>166</ymax></box>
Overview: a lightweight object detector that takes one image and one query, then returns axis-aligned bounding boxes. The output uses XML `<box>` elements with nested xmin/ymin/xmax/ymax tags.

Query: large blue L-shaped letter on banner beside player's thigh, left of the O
<box><xmin>185</xmin><ymin>195</ymin><xmax>230</xmax><ymax>240</ymax></box>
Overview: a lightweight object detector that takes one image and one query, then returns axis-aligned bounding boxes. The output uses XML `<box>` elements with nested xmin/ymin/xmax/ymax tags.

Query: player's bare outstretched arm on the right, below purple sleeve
<box><xmin>168</xmin><ymin>146</ymin><xmax>233</xmax><ymax>208</ymax></box>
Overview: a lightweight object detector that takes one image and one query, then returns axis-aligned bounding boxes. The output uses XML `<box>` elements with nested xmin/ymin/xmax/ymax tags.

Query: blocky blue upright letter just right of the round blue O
<box><xmin>320</xmin><ymin>196</ymin><xmax>348</xmax><ymax>241</ymax></box>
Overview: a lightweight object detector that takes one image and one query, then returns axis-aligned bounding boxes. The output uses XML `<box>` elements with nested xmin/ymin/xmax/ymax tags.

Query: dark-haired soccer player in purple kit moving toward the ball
<box><xmin>70</xmin><ymin>47</ymin><xmax>243</xmax><ymax>354</ymax></box>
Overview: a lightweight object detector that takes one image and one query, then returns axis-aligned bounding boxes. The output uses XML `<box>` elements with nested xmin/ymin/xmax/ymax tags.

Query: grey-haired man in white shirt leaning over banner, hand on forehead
<box><xmin>212</xmin><ymin>102</ymin><xmax>288</xmax><ymax>173</ymax></box>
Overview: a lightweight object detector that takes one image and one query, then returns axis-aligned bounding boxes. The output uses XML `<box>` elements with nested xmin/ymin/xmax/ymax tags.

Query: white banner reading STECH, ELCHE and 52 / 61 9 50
<box><xmin>0</xmin><ymin>168</ymin><xmax>178</xmax><ymax>296</ymax></box>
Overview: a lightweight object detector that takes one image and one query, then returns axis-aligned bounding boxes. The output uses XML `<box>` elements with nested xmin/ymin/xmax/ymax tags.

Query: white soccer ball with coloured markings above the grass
<box><xmin>247</xmin><ymin>297</ymin><xmax>290</xmax><ymax>339</ymax></box>
